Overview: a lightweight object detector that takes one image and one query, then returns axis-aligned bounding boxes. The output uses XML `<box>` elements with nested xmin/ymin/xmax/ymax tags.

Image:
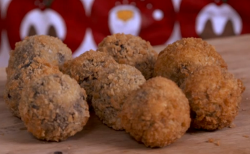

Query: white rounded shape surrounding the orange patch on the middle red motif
<box><xmin>108</xmin><ymin>5</ymin><xmax>141</xmax><ymax>35</ymax></box>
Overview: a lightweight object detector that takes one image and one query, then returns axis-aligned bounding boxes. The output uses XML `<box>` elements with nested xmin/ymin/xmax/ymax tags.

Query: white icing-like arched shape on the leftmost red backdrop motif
<box><xmin>20</xmin><ymin>9</ymin><xmax>66</xmax><ymax>40</ymax></box>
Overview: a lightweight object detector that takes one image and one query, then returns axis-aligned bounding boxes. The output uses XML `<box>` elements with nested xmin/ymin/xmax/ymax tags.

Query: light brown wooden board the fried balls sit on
<box><xmin>0</xmin><ymin>35</ymin><xmax>250</xmax><ymax>154</ymax></box>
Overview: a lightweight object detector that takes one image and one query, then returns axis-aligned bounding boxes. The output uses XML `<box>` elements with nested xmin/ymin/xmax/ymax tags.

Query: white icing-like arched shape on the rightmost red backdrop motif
<box><xmin>196</xmin><ymin>3</ymin><xmax>242</xmax><ymax>35</ymax></box>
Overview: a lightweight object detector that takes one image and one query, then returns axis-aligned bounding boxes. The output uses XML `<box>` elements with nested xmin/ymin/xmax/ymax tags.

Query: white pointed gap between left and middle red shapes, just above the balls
<box><xmin>73</xmin><ymin>28</ymin><xmax>97</xmax><ymax>58</ymax></box>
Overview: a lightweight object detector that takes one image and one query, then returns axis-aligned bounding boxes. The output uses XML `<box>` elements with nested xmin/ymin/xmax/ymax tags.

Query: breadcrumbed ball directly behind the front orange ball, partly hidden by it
<box><xmin>92</xmin><ymin>64</ymin><xmax>146</xmax><ymax>130</ymax></box>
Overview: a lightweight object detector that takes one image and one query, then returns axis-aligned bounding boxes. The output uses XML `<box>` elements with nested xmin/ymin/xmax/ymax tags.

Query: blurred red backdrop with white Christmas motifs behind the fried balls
<box><xmin>0</xmin><ymin>0</ymin><xmax>250</xmax><ymax>67</ymax></box>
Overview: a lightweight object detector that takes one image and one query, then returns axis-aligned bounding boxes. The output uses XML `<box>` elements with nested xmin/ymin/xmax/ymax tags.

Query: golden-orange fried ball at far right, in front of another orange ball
<box><xmin>181</xmin><ymin>66</ymin><xmax>244</xmax><ymax>130</ymax></box>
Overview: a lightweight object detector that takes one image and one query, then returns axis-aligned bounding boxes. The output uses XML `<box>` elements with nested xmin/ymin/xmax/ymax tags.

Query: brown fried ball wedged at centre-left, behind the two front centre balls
<box><xmin>60</xmin><ymin>50</ymin><xmax>117</xmax><ymax>104</ymax></box>
